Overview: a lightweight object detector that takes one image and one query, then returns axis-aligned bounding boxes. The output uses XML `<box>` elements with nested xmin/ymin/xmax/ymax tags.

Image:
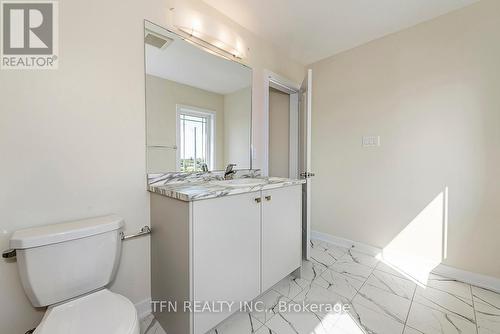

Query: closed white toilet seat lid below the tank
<box><xmin>34</xmin><ymin>289</ymin><xmax>139</xmax><ymax>334</ymax></box>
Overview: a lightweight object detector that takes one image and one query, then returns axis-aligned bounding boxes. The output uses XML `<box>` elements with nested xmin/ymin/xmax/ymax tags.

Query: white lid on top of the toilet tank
<box><xmin>10</xmin><ymin>215</ymin><xmax>124</xmax><ymax>249</ymax></box>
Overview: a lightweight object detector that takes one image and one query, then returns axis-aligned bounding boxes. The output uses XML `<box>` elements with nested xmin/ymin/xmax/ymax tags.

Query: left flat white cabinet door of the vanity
<box><xmin>192</xmin><ymin>192</ymin><xmax>261</xmax><ymax>334</ymax></box>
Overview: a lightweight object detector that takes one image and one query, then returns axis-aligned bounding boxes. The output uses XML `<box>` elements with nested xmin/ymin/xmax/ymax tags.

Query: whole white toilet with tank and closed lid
<box><xmin>10</xmin><ymin>215</ymin><xmax>143</xmax><ymax>334</ymax></box>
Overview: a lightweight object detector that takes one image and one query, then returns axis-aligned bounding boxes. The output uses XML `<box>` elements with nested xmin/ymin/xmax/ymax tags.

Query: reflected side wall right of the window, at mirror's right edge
<box><xmin>224</xmin><ymin>87</ymin><xmax>252</xmax><ymax>168</ymax></box>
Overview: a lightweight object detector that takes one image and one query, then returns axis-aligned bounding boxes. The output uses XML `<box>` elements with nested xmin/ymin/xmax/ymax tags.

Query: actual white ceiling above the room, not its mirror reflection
<box><xmin>203</xmin><ymin>0</ymin><xmax>479</xmax><ymax>64</ymax></box>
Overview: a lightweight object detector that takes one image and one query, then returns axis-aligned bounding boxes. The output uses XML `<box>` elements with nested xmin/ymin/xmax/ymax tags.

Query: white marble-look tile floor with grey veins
<box><xmin>141</xmin><ymin>240</ymin><xmax>500</xmax><ymax>334</ymax></box>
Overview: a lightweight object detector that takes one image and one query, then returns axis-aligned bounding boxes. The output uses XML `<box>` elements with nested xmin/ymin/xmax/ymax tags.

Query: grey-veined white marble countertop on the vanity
<box><xmin>148</xmin><ymin>177</ymin><xmax>305</xmax><ymax>202</ymax></box>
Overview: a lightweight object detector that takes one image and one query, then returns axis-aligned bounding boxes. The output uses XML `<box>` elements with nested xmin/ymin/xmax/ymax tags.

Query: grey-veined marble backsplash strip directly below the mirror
<box><xmin>148</xmin><ymin>169</ymin><xmax>261</xmax><ymax>186</ymax></box>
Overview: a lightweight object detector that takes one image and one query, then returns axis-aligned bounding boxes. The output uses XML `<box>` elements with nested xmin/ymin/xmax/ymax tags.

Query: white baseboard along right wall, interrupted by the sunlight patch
<box><xmin>311</xmin><ymin>231</ymin><xmax>500</xmax><ymax>293</ymax></box>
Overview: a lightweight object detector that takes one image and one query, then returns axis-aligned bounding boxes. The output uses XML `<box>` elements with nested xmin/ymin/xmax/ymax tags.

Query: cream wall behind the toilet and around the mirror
<box><xmin>0</xmin><ymin>0</ymin><xmax>304</xmax><ymax>334</ymax></box>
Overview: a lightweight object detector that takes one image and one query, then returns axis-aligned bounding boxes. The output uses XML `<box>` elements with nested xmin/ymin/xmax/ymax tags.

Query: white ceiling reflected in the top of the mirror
<box><xmin>145</xmin><ymin>29</ymin><xmax>252</xmax><ymax>95</ymax></box>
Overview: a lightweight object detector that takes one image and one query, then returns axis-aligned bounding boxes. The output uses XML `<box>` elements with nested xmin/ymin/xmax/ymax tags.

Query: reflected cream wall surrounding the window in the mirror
<box><xmin>146</xmin><ymin>75</ymin><xmax>225</xmax><ymax>173</ymax></box>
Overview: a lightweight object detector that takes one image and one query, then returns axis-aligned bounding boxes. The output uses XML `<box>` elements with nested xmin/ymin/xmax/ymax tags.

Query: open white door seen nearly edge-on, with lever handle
<box><xmin>299</xmin><ymin>69</ymin><xmax>314</xmax><ymax>260</ymax></box>
